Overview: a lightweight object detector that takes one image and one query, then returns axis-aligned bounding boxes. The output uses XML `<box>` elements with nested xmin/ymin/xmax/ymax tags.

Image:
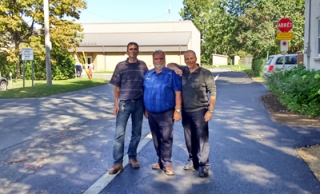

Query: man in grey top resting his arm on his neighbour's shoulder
<box><xmin>168</xmin><ymin>50</ymin><xmax>216</xmax><ymax>177</ymax></box>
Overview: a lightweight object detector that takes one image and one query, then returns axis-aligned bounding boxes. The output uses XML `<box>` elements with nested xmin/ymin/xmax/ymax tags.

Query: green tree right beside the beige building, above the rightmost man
<box><xmin>180</xmin><ymin>0</ymin><xmax>242</xmax><ymax>63</ymax></box>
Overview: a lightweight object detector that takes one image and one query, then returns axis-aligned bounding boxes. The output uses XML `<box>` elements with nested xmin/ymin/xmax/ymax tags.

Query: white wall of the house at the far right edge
<box><xmin>304</xmin><ymin>0</ymin><xmax>320</xmax><ymax>70</ymax></box>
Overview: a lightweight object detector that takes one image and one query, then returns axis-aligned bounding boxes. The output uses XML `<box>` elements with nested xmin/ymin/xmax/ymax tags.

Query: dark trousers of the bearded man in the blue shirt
<box><xmin>148</xmin><ymin>109</ymin><xmax>173</xmax><ymax>168</ymax></box>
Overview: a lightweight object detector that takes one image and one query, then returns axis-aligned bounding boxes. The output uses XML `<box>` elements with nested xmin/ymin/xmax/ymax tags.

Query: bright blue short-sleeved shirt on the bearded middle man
<box><xmin>143</xmin><ymin>67</ymin><xmax>182</xmax><ymax>113</ymax></box>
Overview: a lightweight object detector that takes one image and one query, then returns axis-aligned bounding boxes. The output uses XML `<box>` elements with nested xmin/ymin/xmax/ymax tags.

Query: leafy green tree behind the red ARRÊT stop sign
<box><xmin>229</xmin><ymin>0</ymin><xmax>304</xmax><ymax>56</ymax></box>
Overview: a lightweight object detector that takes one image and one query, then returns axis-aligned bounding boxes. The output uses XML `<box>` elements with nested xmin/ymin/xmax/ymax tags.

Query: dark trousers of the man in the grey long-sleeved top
<box><xmin>182</xmin><ymin>109</ymin><xmax>210</xmax><ymax>168</ymax></box>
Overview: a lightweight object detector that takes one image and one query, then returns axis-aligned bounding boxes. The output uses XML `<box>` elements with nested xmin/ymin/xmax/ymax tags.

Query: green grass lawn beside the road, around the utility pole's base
<box><xmin>0</xmin><ymin>78</ymin><xmax>108</xmax><ymax>98</ymax></box>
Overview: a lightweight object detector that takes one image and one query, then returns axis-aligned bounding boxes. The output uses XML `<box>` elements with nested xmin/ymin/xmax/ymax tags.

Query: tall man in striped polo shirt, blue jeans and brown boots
<box><xmin>109</xmin><ymin>42</ymin><xmax>148</xmax><ymax>174</ymax></box>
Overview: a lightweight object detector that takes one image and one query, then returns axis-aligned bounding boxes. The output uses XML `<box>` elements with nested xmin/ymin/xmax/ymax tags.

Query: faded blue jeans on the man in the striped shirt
<box><xmin>113</xmin><ymin>99</ymin><xmax>143</xmax><ymax>165</ymax></box>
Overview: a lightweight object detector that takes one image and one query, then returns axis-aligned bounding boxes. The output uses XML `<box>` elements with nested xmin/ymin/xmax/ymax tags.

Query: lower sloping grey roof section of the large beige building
<box><xmin>80</xmin><ymin>32</ymin><xmax>191</xmax><ymax>47</ymax></box>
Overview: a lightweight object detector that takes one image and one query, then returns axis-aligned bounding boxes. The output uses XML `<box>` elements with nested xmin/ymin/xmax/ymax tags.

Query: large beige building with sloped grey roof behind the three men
<box><xmin>70</xmin><ymin>21</ymin><xmax>201</xmax><ymax>71</ymax></box>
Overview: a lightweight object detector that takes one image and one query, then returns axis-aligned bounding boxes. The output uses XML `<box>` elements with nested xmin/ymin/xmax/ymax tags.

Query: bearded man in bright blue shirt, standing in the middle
<box><xmin>143</xmin><ymin>50</ymin><xmax>182</xmax><ymax>175</ymax></box>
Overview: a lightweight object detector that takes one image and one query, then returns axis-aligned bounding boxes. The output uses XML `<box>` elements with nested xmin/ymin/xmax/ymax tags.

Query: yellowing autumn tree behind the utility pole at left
<box><xmin>0</xmin><ymin>0</ymin><xmax>86</xmax><ymax>78</ymax></box>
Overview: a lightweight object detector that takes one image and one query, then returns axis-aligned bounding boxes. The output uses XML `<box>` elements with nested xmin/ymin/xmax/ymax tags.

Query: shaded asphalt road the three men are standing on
<box><xmin>0</xmin><ymin>72</ymin><xmax>320</xmax><ymax>194</ymax></box>
